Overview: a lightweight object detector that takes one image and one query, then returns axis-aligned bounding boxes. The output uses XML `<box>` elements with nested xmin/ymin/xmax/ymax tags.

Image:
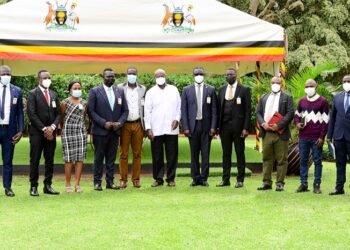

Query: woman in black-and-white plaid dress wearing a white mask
<box><xmin>61</xmin><ymin>81</ymin><xmax>87</xmax><ymax>193</ymax></box>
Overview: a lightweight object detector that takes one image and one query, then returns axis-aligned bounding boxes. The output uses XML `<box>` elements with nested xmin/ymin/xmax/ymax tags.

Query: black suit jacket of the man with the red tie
<box><xmin>27</xmin><ymin>87</ymin><xmax>60</xmax><ymax>135</ymax></box>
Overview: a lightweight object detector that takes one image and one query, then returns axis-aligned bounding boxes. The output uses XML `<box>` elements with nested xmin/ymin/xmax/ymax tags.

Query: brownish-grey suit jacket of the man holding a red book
<box><xmin>256</xmin><ymin>92</ymin><xmax>294</xmax><ymax>141</ymax></box>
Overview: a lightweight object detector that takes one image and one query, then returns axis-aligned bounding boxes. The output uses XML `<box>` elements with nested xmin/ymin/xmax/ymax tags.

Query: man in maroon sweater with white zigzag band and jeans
<box><xmin>294</xmin><ymin>79</ymin><xmax>329</xmax><ymax>194</ymax></box>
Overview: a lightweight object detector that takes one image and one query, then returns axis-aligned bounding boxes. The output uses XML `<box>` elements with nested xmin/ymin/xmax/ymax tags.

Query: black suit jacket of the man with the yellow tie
<box><xmin>218</xmin><ymin>82</ymin><xmax>252</xmax><ymax>133</ymax></box>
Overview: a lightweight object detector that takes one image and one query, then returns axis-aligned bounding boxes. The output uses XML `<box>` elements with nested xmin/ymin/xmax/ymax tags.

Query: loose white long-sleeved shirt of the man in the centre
<box><xmin>145</xmin><ymin>85</ymin><xmax>181</xmax><ymax>136</ymax></box>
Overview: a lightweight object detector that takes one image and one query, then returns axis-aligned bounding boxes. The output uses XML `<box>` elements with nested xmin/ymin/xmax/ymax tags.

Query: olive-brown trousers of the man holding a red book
<box><xmin>263</xmin><ymin>132</ymin><xmax>288</xmax><ymax>185</ymax></box>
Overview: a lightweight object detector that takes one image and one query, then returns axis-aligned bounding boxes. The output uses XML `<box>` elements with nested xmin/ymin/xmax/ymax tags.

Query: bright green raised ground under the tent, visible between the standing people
<box><xmin>13</xmin><ymin>137</ymin><xmax>261</xmax><ymax>165</ymax></box>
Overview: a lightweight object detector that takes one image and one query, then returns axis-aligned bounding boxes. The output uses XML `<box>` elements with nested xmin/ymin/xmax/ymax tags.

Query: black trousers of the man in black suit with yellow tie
<box><xmin>220</xmin><ymin>123</ymin><xmax>245</xmax><ymax>182</ymax></box>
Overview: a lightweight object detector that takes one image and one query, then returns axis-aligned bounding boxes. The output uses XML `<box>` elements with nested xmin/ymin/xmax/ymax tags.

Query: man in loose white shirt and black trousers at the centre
<box><xmin>145</xmin><ymin>69</ymin><xmax>181</xmax><ymax>187</ymax></box>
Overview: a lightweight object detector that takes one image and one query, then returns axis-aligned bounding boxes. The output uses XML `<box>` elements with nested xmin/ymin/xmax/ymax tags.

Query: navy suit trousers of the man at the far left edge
<box><xmin>0</xmin><ymin>125</ymin><xmax>15</xmax><ymax>188</ymax></box>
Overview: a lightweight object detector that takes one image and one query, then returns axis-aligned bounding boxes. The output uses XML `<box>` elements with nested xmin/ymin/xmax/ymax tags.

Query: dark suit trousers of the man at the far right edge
<box><xmin>334</xmin><ymin>138</ymin><xmax>350</xmax><ymax>190</ymax></box>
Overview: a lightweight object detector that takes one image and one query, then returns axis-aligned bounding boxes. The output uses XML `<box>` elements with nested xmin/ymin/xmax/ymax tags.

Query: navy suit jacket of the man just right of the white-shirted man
<box><xmin>181</xmin><ymin>84</ymin><xmax>217</xmax><ymax>133</ymax></box>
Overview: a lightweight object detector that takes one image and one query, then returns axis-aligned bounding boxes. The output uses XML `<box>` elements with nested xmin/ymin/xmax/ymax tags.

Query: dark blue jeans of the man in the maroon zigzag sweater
<box><xmin>299</xmin><ymin>139</ymin><xmax>322</xmax><ymax>185</ymax></box>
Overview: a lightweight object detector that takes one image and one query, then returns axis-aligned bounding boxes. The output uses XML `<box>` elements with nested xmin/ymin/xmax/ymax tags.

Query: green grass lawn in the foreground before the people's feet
<box><xmin>0</xmin><ymin>163</ymin><xmax>350</xmax><ymax>249</ymax></box>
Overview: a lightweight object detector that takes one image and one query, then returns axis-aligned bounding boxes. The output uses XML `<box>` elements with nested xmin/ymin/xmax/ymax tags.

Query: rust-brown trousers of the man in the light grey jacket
<box><xmin>119</xmin><ymin>121</ymin><xmax>144</xmax><ymax>181</ymax></box>
